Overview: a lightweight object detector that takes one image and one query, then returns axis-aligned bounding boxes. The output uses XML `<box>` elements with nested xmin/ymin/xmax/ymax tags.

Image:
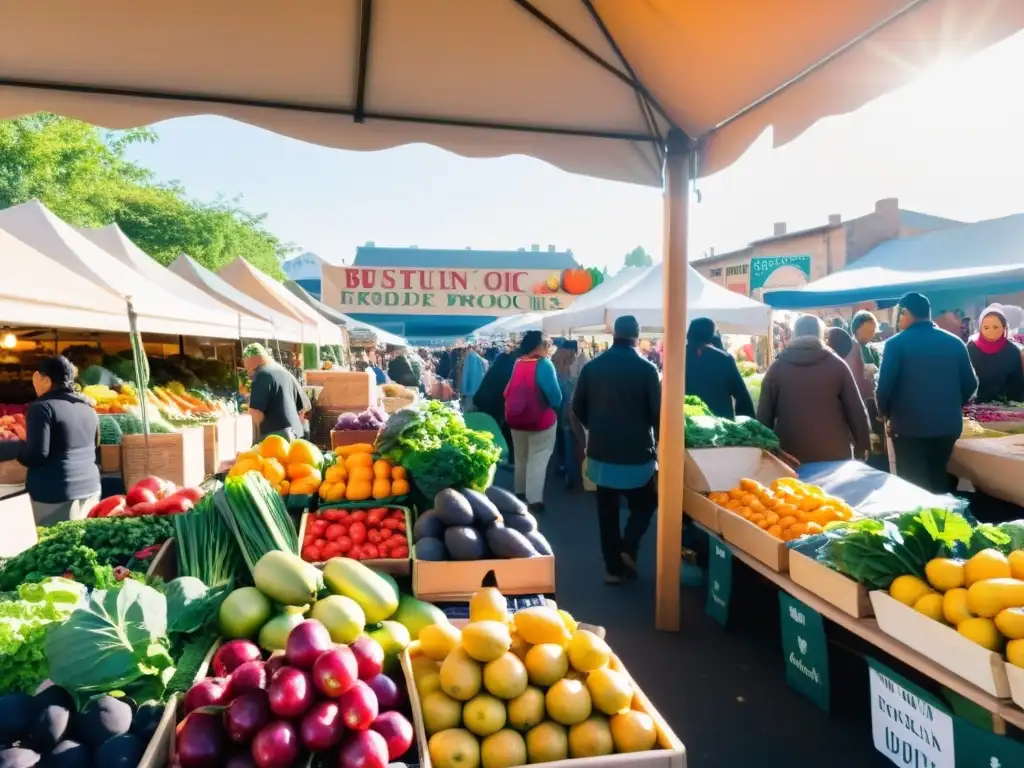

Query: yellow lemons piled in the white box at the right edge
<box><xmin>889</xmin><ymin>549</ymin><xmax>1024</xmax><ymax>668</ymax></box>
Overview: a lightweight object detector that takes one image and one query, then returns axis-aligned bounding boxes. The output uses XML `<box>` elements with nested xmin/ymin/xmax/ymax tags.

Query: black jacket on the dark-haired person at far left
<box><xmin>17</xmin><ymin>389</ymin><xmax>99</xmax><ymax>504</ymax></box>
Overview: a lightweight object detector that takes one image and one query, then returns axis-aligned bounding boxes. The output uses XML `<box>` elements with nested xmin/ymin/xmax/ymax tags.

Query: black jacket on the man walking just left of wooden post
<box><xmin>572</xmin><ymin>344</ymin><xmax>662</xmax><ymax>465</ymax></box>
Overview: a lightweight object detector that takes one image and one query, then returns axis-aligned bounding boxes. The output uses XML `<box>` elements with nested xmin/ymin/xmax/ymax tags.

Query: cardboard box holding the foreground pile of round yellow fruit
<box><xmin>399</xmin><ymin>642</ymin><xmax>686</xmax><ymax>768</ymax></box>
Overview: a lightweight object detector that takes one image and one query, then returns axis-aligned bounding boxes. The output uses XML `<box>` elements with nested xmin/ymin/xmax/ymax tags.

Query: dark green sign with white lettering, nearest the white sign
<box><xmin>778</xmin><ymin>592</ymin><xmax>831</xmax><ymax>712</ymax></box>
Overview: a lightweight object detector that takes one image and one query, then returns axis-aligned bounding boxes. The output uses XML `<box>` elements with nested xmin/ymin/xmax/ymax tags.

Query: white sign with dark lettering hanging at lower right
<box><xmin>867</xmin><ymin>656</ymin><xmax>963</xmax><ymax>768</ymax></box>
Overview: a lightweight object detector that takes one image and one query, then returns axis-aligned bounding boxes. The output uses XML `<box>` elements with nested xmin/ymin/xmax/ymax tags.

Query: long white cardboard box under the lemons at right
<box><xmin>870</xmin><ymin>590</ymin><xmax>1010</xmax><ymax>698</ymax></box>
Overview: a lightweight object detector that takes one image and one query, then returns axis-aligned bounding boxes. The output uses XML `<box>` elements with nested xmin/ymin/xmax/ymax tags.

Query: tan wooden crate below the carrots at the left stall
<box><xmin>121</xmin><ymin>427</ymin><xmax>206</xmax><ymax>488</ymax></box>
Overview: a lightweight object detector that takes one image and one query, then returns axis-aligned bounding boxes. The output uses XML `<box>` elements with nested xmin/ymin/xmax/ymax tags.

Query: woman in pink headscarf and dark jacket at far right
<box><xmin>967</xmin><ymin>304</ymin><xmax>1024</xmax><ymax>402</ymax></box>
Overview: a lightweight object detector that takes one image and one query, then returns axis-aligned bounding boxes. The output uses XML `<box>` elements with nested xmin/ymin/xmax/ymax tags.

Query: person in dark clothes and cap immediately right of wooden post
<box><xmin>686</xmin><ymin>317</ymin><xmax>754</xmax><ymax>419</ymax></box>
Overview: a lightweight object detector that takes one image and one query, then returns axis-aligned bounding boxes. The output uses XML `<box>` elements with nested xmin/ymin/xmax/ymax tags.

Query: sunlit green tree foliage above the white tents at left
<box><xmin>0</xmin><ymin>113</ymin><xmax>294</xmax><ymax>280</ymax></box>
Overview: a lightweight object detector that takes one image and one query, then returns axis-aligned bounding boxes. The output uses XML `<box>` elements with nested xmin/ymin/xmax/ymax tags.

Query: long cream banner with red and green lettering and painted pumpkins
<box><xmin>321</xmin><ymin>264</ymin><xmax>575</xmax><ymax>316</ymax></box>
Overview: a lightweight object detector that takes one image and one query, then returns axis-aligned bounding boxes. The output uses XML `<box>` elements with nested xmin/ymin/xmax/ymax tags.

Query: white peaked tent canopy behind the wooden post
<box><xmin>573</xmin><ymin>264</ymin><xmax>771</xmax><ymax>336</ymax></box>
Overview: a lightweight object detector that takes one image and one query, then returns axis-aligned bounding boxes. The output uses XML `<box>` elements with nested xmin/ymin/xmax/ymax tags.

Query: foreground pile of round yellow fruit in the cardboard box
<box><xmin>411</xmin><ymin>588</ymin><xmax>658</xmax><ymax>768</ymax></box>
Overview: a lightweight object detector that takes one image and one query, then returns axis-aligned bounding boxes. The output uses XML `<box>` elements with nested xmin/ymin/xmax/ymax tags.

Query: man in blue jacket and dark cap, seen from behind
<box><xmin>877</xmin><ymin>293</ymin><xmax>978</xmax><ymax>494</ymax></box>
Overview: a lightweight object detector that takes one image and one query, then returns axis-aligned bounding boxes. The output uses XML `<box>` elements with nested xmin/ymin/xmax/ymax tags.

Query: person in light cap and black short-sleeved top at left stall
<box><xmin>242</xmin><ymin>344</ymin><xmax>311</xmax><ymax>440</ymax></box>
